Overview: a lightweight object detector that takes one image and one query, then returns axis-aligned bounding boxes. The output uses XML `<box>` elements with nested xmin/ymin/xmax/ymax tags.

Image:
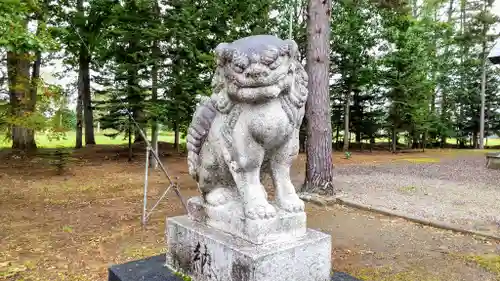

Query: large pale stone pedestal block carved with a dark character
<box><xmin>166</xmin><ymin>216</ymin><xmax>331</xmax><ymax>281</ymax></box>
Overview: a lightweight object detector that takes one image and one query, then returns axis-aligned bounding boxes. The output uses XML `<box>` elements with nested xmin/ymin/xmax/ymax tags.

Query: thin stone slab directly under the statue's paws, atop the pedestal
<box><xmin>187</xmin><ymin>197</ymin><xmax>307</xmax><ymax>244</ymax></box>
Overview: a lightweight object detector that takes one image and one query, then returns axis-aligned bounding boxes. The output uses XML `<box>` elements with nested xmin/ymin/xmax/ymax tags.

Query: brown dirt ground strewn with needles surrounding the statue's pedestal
<box><xmin>0</xmin><ymin>147</ymin><xmax>500</xmax><ymax>281</ymax></box>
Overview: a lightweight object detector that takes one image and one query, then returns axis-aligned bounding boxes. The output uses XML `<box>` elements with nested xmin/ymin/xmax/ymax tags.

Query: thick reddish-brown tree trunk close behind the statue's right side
<box><xmin>302</xmin><ymin>0</ymin><xmax>334</xmax><ymax>195</ymax></box>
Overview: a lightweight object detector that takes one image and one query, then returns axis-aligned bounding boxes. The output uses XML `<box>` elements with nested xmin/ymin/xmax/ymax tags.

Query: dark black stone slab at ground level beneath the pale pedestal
<box><xmin>108</xmin><ymin>255</ymin><xmax>360</xmax><ymax>281</ymax></box>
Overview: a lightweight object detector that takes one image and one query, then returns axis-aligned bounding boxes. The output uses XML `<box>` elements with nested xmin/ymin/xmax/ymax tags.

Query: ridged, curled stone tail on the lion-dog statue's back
<box><xmin>187</xmin><ymin>97</ymin><xmax>216</xmax><ymax>180</ymax></box>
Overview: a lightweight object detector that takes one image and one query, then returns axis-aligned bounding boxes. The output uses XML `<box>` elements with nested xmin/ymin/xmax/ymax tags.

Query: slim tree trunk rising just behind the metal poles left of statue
<box><xmin>150</xmin><ymin>1</ymin><xmax>160</xmax><ymax>169</ymax></box>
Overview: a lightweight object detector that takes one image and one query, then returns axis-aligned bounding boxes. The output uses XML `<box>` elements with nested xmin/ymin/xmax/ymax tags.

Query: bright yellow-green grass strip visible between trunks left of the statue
<box><xmin>0</xmin><ymin>132</ymin><xmax>185</xmax><ymax>148</ymax></box>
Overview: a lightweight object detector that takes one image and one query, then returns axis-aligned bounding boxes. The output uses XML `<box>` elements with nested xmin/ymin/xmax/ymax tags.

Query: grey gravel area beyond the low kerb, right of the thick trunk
<box><xmin>328</xmin><ymin>153</ymin><xmax>500</xmax><ymax>237</ymax></box>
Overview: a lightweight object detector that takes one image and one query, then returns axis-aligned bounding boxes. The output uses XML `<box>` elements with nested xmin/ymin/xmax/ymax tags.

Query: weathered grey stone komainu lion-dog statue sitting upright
<box><xmin>187</xmin><ymin>35</ymin><xmax>308</xmax><ymax>219</ymax></box>
